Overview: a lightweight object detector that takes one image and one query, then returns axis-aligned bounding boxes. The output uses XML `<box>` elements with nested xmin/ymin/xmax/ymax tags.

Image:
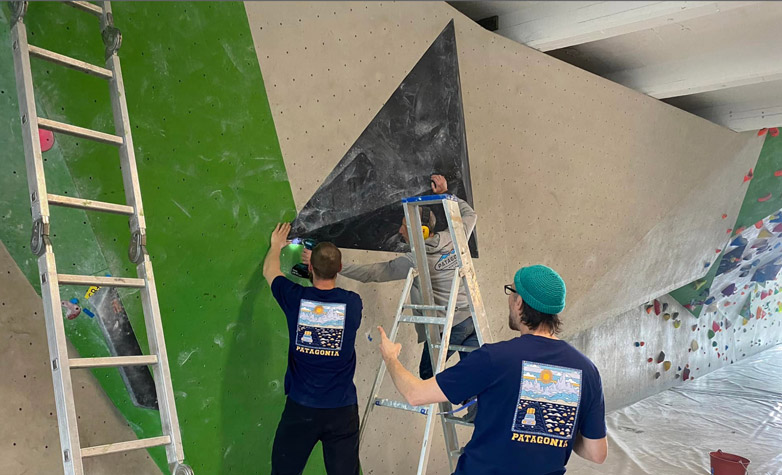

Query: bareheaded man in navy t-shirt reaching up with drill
<box><xmin>263</xmin><ymin>223</ymin><xmax>363</xmax><ymax>475</ymax></box>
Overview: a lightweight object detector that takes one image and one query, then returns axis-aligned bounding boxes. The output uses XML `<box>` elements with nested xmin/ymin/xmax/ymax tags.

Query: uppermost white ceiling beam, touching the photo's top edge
<box><xmin>496</xmin><ymin>1</ymin><xmax>758</xmax><ymax>51</ymax></box>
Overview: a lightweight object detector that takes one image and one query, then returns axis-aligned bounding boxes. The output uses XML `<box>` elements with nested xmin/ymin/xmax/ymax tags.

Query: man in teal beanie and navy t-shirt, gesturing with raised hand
<box><xmin>380</xmin><ymin>266</ymin><xmax>607</xmax><ymax>475</ymax></box>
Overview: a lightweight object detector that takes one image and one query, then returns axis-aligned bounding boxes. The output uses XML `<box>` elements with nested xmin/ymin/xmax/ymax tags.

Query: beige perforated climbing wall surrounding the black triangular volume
<box><xmin>245</xmin><ymin>2</ymin><xmax>762</xmax><ymax>473</ymax></box>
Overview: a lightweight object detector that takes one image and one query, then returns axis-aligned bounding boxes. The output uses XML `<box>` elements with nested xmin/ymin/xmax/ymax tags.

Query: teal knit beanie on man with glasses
<box><xmin>513</xmin><ymin>265</ymin><xmax>566</xmax><ymax>315</ymax></box>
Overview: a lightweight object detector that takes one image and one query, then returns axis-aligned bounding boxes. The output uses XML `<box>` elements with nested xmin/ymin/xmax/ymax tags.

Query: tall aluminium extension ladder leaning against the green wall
<box><xmin>11</xmin><ymin>1</ymin><xmax>193</xmax><ymax>475</ymax></box>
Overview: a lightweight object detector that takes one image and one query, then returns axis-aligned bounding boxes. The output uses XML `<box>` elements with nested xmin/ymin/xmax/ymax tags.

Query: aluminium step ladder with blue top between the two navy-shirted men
<box><xmin>360</xmin><ymin>195</ymin><xmax>491</xmax><ymax>475</ymax></box>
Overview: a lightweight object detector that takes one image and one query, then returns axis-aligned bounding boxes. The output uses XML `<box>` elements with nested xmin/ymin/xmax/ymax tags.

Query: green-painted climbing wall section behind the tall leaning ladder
<box><xmin>0</xmin><ymin>2</ymin><xmax>310</xmax><ymax>474</ymax></box>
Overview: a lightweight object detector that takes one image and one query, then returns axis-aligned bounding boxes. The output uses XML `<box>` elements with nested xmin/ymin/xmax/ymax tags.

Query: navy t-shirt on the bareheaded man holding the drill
<box><xmin>272</xmin><ymin>276</ymin><xmax>363</xmax><ymax>408</ymax></box>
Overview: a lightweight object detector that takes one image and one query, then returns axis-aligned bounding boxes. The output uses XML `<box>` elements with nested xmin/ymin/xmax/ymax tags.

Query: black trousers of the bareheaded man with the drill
<box><xmin>272</xmin><ymin>398</ymin><xmax>359</xmax><ymax>475</ymax></box>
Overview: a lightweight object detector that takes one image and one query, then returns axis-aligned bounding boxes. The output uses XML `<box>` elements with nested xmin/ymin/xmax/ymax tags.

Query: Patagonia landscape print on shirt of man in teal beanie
<box><xmin>511</xmin><ymin>361</ymin><xmax>581</xmax><ymax>447</ymax></box>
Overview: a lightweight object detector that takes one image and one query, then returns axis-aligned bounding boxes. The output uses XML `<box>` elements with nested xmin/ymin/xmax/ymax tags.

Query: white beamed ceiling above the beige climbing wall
<box><xmin>451</xmin><ymin>1</ymin><xmax>782</xmax><ymax>131</ymax></box>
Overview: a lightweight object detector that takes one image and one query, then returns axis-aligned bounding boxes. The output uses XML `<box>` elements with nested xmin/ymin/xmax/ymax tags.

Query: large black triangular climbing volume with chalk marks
<box><xmin>291</xmin><ymin>20</ymin><xmax>477</xmax><ymax>256</ymax></box>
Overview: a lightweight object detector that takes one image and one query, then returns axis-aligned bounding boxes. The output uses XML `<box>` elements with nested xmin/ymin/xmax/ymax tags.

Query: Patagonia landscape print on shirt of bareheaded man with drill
<box><xmin>296</xmin><ymin>299</ymin><xmax>346</xmax><ymax>356</ymax></box>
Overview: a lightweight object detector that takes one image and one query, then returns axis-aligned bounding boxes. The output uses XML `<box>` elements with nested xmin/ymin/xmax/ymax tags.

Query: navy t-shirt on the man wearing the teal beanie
<box><xmin>436</xmin><ymin>335</ymin><xmax>606</xmax><ymax>475</ymax></box>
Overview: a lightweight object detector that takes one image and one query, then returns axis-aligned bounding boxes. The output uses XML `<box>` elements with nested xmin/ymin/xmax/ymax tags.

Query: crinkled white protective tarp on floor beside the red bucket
<box><xmin>567</xmin><ymin>345</ymin><xmax>782</xmax><ymax>475</ymax></box>
